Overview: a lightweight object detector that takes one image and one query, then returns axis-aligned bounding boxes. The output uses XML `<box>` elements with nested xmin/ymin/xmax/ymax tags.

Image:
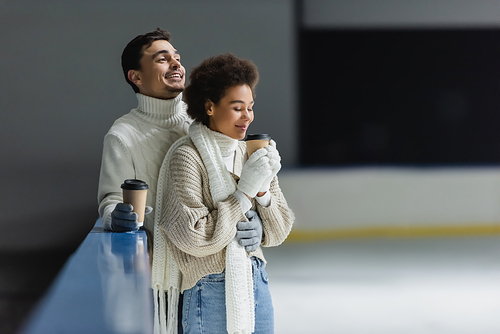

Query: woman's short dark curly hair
<box><xmin>184</xmin><ymin>53</ymin><xmax>259</xmax><ymax>126</ymax></box>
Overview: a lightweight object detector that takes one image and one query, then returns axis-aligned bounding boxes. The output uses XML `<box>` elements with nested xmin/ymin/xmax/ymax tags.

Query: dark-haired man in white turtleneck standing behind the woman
<box><xmin>98</xmin><ymin>28</ymin><xmax>191</xmax><ymax>234</ymax></box>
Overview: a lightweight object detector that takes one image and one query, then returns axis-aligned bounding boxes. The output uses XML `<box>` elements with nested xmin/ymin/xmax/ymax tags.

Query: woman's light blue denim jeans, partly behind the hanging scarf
<box><xmin>182</xmin><ymin>258</ymin><xmax>274</xmax><ymax>334</ymax></box>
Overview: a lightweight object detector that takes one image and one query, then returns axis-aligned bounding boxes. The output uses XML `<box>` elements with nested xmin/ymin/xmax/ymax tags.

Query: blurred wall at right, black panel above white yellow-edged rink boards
<box><xmin>288</xmin><ymin>0</ymin><xmax>500</xmax><ymax>236</ymax></box>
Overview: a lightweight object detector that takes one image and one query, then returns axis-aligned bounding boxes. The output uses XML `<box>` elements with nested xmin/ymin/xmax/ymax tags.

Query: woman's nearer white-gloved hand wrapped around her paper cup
<box><xmin>237</xmin><ymin>148</ymin><xmax>272</xmax><ymax>198</ymax></box>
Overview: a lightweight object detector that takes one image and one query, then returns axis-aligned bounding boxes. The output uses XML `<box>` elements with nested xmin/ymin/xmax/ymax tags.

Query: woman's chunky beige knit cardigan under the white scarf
<box><xmin>161</xmin><ymin>141</ymin><xmax>294</xmax><ymax>291</ymax></box>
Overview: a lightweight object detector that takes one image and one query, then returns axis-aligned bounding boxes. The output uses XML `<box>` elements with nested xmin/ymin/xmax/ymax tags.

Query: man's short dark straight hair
<box><xmin>122</xmin><ymin>28</ymin><xmax>170</xmax><ymax>93</ymax></box>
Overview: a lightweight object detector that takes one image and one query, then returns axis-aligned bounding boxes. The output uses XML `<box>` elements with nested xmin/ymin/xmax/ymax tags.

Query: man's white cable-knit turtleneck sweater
<box><xmin>97</xmin><ymin>93</ymin><xmax>192</xmax><ymax>232</ymax></box>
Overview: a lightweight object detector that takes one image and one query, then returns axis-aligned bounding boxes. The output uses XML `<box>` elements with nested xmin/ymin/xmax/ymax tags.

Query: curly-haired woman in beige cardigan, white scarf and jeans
<box><xmin>152</xmin><ymin>54</ymin><xmax>294</xmax><ymax>334</ymax></box>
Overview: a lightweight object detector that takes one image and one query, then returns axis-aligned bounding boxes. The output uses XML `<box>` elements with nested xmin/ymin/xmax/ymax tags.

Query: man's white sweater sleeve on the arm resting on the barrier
<box><xmin>97</xmin><ymin>133</ymin><xmax>135</xmax><ymax>231</ymax></box>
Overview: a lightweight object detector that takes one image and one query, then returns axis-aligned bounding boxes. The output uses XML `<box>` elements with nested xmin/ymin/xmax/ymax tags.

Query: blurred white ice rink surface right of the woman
<box><xmin>264</xmin><ymin>237</ymin><xmax>500</xmax><ymax>334</ymax></box>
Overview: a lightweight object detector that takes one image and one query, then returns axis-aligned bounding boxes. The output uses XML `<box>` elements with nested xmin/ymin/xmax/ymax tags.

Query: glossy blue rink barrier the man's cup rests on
<box><xmin>22</xmin><ymin>219</ymin><xmax>153</xmax><ymax>334</ymax></box>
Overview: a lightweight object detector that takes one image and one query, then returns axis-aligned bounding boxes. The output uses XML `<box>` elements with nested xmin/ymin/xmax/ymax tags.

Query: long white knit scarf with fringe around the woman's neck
<box><xmin>152</xmin><ymin>122</ymin><xmax>255</xmax><ymax>334</ymax></box>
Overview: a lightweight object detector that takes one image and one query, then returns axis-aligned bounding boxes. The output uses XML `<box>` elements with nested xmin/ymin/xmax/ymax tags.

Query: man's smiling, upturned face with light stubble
<box><xmin>128</xmin><ymin>40</ymin><xmax>186</xmax><ymax>99</ymax></box>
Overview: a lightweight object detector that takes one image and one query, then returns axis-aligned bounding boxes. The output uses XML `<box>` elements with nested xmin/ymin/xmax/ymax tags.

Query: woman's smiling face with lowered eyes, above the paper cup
<box><xmin>206</xmin><ymin>85</ymin><xmax>254</xmax><ymax>140</ymax></box>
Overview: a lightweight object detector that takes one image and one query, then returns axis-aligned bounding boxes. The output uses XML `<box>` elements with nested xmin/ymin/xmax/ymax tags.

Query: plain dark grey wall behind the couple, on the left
<box><xmin>0</xmin><ymin>0</ymin><xmax>296</xmax><ymax>250</ymax></box>
